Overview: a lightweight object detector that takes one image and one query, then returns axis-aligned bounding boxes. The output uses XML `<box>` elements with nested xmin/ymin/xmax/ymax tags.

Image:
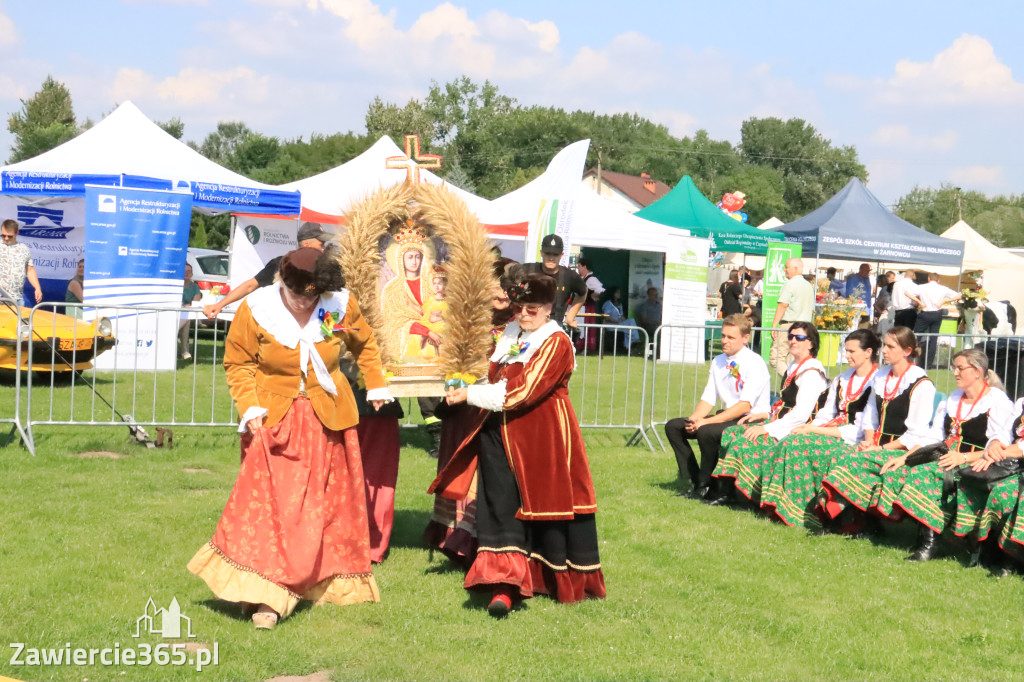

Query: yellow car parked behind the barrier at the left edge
<box><xmin>0</xmin><ymin>302</ymin><xmax>117</xmax><ymax>372</ymax></box>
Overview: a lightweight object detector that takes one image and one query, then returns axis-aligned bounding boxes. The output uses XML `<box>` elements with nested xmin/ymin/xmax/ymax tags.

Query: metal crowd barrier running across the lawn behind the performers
<box><xmin>0</xmin><ymin>304</ymin><xmax>1024</xmax><ymax>453</ymax></box>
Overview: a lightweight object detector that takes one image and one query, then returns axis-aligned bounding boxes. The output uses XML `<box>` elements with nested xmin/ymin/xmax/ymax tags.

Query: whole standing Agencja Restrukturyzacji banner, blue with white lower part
<box><xmin>84</xmin><ymin>185</ymin><xmax>191</xmax><ymax>370</ymax></box>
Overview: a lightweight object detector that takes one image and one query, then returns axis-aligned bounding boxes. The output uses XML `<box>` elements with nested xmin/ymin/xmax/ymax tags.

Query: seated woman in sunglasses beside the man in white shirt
<box><xmin>711</xmin><ymin>322</ymin><xmax>828</xmax><ymax>504</ymax></box>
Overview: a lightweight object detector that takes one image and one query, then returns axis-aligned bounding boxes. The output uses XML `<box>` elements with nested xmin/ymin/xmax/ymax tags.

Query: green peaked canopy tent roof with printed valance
<box><xmin>633</xmin><ymin>175</ymin><xmax>785</xmax><ymax>255</ymax></box>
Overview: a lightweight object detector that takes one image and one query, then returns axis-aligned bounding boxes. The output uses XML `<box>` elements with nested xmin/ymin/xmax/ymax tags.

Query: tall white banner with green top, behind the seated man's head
<box><xmin>658</xmin><ymin>235</ymin><xmax>711</xmax><ymax>363</ymax></box>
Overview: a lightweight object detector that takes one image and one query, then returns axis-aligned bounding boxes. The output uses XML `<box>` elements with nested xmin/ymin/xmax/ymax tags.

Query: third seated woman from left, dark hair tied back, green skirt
<box><xmin>821</xmin><ymin>327</ymin><xmax>935</xmax><ymax>532</ymax></box>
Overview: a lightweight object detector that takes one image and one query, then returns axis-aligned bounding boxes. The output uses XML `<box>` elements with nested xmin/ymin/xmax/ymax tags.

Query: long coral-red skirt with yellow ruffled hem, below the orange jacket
<box><xmin>188</xmin><ymin>398</ymin><xmax>380</xmax><ymax>616</ymax></box>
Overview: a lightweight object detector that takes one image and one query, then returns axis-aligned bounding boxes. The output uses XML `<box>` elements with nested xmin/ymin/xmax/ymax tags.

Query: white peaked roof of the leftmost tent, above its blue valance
<box><xmin>0</xmin><ymin>101</ymin><xmax>299</xmax><ymax>209</ymax></box>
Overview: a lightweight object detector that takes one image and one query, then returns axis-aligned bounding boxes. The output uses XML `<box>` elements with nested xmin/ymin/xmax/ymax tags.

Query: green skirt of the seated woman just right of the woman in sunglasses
<box><xmin>761</xmin><ymin>434</ymin><xmax>853</xmax><ymax>528</ymax></box>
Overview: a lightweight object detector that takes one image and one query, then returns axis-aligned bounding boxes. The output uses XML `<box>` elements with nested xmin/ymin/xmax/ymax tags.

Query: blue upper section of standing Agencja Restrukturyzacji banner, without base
<box><xmin>85</xmin><ymin>186</ymin><xmax>191</xmax><ymax>306</ymax></box>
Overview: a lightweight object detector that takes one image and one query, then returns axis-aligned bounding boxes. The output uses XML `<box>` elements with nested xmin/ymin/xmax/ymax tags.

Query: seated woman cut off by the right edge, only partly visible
<box><xmin>962</xmin><ymin>398</ymin><xmax>1024</xmax><ymax>577</ymax></box>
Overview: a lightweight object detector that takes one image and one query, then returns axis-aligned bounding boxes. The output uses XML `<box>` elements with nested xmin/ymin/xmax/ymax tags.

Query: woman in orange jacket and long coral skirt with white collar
<box><xmin>188</xmin><ymin>249</ymin><xmax>391</xmax><ymax>628</ymax></box>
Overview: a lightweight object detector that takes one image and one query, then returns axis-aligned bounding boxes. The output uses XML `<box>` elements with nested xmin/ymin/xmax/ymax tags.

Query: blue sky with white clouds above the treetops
<box><xmin>0</xmin><ymin>0</ymin><xmax>1024</xmax><ymax>203</ymax></box>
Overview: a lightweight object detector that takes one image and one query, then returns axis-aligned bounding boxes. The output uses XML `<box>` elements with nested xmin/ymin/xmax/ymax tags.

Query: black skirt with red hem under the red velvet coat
<box><xmin>465</xmin><ymin>415</ymin><xmax>605</xmax><ymax>603</ymax></box>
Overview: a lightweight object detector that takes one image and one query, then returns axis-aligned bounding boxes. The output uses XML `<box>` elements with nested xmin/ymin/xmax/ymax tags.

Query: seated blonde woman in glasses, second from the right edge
<box><xmin>873</xmin><ymin>348</ymin><xmax>1014</xmax><ymax>561</ymax></box>
